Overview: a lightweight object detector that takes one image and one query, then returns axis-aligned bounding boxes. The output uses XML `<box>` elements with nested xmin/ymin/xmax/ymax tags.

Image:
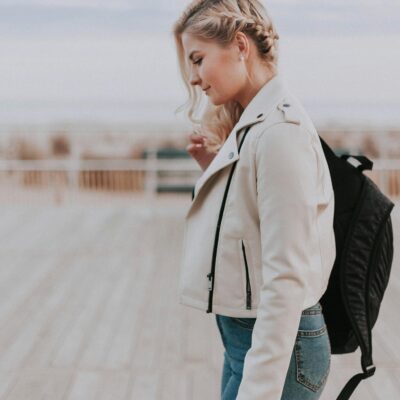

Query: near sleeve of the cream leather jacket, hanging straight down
<box><xmin>237</xmin><ymin>122</ymin><xmax>318</xmax><ymax>400</ymax></box>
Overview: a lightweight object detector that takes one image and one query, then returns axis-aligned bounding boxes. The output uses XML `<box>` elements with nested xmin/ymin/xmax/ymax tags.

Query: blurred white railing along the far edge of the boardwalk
<box><xmin>0</xmin><ymin>157</ymin><xmax>400</xmax><ymax>203</ymax></box>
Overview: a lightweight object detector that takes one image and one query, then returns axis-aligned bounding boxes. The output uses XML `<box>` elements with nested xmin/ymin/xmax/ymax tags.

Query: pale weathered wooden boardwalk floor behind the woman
<box><xmin>0</xmin><ymin>198</ymin><xmax>400</xmax><ymax>400</ymax></box>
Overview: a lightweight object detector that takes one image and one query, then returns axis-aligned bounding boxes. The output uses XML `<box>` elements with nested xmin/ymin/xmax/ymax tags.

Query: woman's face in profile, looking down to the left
<box><xmin>182</xmin><ymin>32</ymin><xmax>246</xmax><ymax>105</ymax></box>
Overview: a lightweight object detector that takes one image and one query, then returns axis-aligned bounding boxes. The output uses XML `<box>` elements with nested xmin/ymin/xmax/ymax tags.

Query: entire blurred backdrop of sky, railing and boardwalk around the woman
<box><xmin>0</xmin><ymin>0</ymin><xmax>400</xmax><ymax>400</ymax></box>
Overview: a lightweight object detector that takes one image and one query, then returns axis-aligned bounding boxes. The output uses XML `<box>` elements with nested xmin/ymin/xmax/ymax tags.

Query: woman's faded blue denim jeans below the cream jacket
<box><xmin>216</xmin><ymin>303</ymin><xmax>331</xmax><ymax>400</ymax></box>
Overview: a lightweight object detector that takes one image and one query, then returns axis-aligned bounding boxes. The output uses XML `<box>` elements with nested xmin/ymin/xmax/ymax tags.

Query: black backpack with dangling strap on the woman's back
<box><xmin>320</xmin><ymin>137</ymin><xmax>394</xmax><ymax>400</ymax></box>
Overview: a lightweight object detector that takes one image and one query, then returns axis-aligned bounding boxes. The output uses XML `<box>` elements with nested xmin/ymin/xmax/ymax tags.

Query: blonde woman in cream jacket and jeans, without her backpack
<box><xmin>174</xmin><ymin>0</ymin><xmax>336</xmax><ymax>400</ymax></box>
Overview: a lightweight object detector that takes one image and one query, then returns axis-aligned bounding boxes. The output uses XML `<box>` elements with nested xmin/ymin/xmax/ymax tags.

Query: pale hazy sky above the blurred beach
<box><xmin>0</xmin><ymin>0</ymin><xmax>400</xmax><ymax>124</ymax></box>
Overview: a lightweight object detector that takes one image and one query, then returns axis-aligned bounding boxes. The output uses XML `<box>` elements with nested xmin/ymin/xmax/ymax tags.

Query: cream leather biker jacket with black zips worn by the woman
<box><xmin>179</xmin><ymin>75</ymin><xmax>336</xmax><ymax>400</ymax></box>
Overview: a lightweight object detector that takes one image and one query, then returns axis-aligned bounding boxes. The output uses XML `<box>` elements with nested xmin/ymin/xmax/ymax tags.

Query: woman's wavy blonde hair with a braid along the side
<box><xmin>173</xmin><ymin>0</ymin><xmax>279</xmax><ymax>152</ymax></box>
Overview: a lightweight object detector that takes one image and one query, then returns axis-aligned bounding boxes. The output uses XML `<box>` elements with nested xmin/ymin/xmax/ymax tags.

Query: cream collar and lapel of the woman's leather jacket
<box><xmin>192</xmin><ymin>74</ymin><xmax>287</xmax><ymax>208</ymax></box>
